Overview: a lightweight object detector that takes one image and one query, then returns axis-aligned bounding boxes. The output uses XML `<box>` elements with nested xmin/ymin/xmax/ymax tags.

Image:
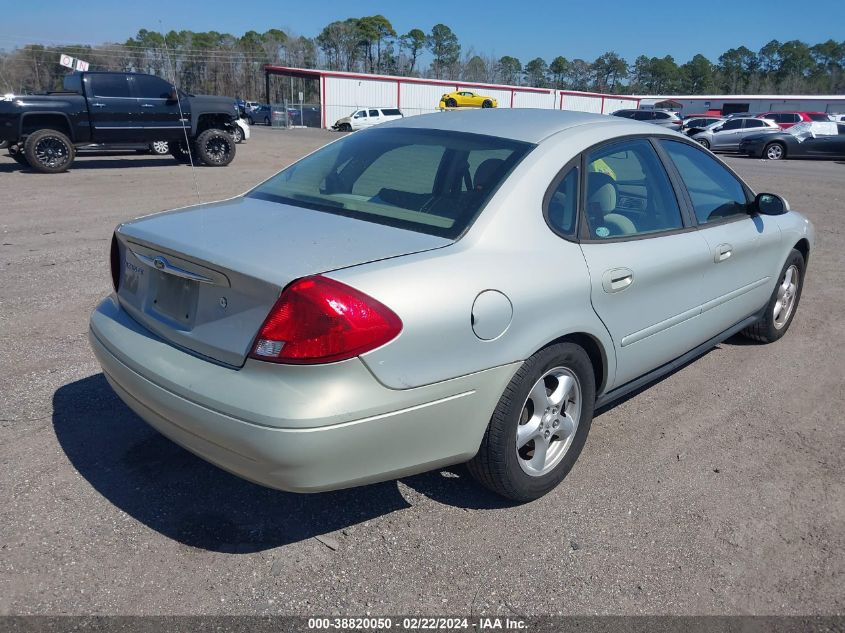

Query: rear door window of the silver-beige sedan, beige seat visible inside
<box><xmin>584</xmin><ymin>139</ymin><xmax>684</xmax><ymax>240</ymax></box>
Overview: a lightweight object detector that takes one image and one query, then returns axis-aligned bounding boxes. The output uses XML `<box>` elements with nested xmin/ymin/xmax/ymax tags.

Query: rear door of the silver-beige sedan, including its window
<box><xmin>581</xmin><ymin>139</ymin><xmax>710</xmax><ymax>387</ymax></box>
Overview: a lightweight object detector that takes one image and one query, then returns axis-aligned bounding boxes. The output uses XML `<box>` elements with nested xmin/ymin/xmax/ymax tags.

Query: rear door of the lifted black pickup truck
<box><xmin>85</xmin><ymin>73</ymin><xmax>138</xmax><ymax>143</ymax></box>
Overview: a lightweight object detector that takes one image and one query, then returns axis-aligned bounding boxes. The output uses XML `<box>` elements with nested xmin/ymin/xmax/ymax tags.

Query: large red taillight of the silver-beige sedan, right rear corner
<box><xmin>250</xmin><ymin>275</ymin><xmax>402</xmax><ymax>365</ymax></box>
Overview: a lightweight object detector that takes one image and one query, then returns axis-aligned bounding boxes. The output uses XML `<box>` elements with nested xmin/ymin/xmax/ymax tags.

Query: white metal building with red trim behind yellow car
<box><xmin>264</xmin><ymin>65</ymin><xmax>639</xmax><ymax>128</ymax></box>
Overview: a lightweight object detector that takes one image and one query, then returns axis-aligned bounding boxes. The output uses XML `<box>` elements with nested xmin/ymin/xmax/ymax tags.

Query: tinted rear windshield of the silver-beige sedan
<box><xmin>247</xmin><ymin>128</ymin><xmax>533</xmax><ymax>239</ymax></box>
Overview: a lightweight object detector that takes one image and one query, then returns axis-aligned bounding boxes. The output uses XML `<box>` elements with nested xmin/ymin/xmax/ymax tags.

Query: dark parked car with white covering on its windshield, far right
<box><xmin>739</xmin><ymin>121</ymin><xmax>845</xmax><ymax>160</ymax></box>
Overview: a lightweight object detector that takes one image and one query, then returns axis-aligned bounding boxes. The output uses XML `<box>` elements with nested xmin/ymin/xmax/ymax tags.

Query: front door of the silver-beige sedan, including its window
<box><xmin>660</xmin><ymin>139</ymin><xmax>782</xmax><ymax>338</ymax></box>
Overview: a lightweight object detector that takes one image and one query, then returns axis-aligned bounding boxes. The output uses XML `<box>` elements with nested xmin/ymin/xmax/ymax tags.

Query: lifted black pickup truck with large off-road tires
<box><xmin>0</xmin><ymin>72</ymin><xmax>238</xmax><ymax>173</ymax></box>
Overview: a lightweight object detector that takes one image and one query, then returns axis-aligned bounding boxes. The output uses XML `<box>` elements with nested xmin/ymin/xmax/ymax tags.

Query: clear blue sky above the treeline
<box><xmin>0</xmin><ymin>0</ymin><xmax>845</xmax><ymax>63</ymax></box>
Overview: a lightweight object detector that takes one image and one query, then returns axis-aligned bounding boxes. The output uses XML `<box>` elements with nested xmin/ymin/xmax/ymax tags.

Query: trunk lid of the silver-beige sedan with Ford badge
<box><xmin>117</xmin><ymin>198</ymin><xmax>452</xmax><ymax>367</ymax></box>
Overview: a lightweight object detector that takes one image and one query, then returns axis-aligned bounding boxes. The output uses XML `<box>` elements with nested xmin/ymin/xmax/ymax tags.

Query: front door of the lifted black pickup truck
<box><xmin>130</xmin><ymin>75</ymin><xmax>191</xmax><ymax>141</ymax></box>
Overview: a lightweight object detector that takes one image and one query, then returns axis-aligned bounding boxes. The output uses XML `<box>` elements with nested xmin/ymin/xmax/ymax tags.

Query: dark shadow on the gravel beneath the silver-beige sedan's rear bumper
<box><xmin>53</xmin><ymin>374</ymin><xmax>510</xmax><ymax>553</ymax></box>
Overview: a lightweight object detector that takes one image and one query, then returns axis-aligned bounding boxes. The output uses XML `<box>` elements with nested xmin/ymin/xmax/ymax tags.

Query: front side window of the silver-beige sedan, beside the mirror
<box><xmin>660</xmin><ymin>140</ymin><xmax>748</xmax><ymax>224</ymax></box>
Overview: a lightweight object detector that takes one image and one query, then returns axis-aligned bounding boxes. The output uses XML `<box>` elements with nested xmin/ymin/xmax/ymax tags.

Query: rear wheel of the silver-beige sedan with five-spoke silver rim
<box><xmin>468</xmin><ymin>343</ymin><xmax>596</xmax><ymax>502</ymax></box>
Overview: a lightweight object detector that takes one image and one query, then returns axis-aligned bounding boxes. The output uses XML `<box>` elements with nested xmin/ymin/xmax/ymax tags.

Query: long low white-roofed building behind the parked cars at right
<box><xmin>638</xmin><ymin>95</ymin><xmax>845</xmax><ymax>114</ymax></box>
